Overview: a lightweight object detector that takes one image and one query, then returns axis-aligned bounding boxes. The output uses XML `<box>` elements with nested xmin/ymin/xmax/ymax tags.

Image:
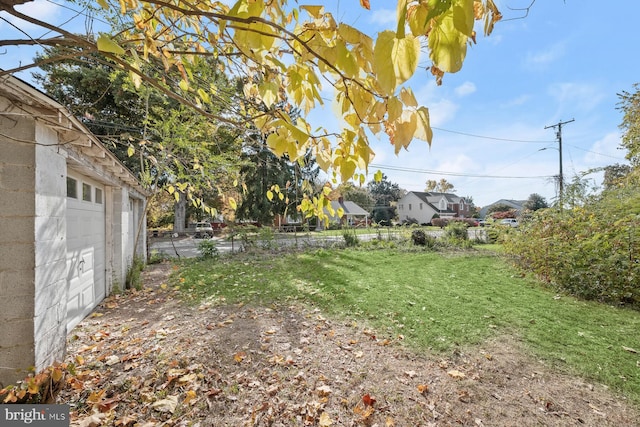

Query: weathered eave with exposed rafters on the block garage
<box><xmin>0</xmin><ymin>75</ymin><xmax>149</xmax><ymax>195</ymax></box>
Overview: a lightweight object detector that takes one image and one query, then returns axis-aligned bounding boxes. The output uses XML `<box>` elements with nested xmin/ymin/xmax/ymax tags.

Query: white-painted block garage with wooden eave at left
<box><xmin>0</xmin><ymin>76</ymin><xmax>146</xmax><ymax>387</ymax></box>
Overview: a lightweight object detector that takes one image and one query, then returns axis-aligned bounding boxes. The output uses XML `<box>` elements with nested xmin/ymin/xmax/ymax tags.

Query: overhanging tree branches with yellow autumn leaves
<box><xmin>0</xmin><ymin>0</ymin><xmax>501</xmax><ymax>217</ymax></box>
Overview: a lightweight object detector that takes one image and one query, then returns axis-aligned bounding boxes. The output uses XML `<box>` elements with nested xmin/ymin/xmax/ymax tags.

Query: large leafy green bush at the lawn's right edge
<box><xmin>504</xmin><ymin>205</ymin><xmax>640</xmax><ymax>307</ymax></box>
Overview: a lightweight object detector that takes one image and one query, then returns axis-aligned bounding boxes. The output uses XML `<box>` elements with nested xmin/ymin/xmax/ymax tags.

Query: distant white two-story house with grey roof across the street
<box><xmin>397</xmin><ymin>191</ymin><xmax>471</xmax><ymax>224</ymax></box>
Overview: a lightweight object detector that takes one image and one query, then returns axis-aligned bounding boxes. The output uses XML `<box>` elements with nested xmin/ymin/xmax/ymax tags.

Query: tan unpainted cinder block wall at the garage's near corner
<box><xmin>0</xmin><ymin>108</ymin><xmax>36</xmax><ymax>385</ymax></box>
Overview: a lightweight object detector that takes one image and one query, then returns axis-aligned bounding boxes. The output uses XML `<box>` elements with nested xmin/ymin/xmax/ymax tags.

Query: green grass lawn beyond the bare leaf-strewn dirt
<box><xmin>176</xmin><ymin>250</ymin><xmax>640</xmax><ymax>404</ymax></box>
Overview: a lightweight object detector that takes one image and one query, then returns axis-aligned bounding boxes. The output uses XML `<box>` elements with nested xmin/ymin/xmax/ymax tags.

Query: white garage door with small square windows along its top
<box><xmin>67</xmin><ymin>173</ymin><xmax>106</xmax><ymax>331</ymax></box>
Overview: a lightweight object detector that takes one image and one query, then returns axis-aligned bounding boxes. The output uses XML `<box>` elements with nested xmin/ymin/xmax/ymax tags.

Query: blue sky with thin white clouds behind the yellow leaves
<box><xmin>0</xmin><ymin>0</ymin><xmax>640</xmax><ymax>206</ymax></box>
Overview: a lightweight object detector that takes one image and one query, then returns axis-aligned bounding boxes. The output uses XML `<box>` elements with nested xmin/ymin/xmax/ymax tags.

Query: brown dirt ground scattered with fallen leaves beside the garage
<box><xmin>58</xmin><ymin>264</ymin><xmax>640</xmax><ymax>427</ymax></box>
